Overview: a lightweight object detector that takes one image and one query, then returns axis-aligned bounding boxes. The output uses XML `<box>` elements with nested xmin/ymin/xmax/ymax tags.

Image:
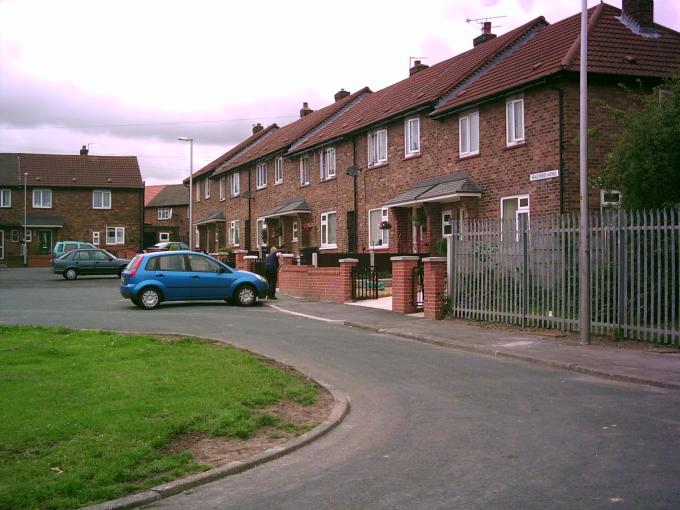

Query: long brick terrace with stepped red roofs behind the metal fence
<box><xmin>183</xmin><ymin>0</ymin><xmax>680</xmax><ymax>254</ymax></box>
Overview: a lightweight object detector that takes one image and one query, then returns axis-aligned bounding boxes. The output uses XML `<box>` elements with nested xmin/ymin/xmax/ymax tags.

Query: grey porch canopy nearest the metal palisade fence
<box><xmin>383</xmin><ymin>172</ymin><xmax>482</xmax><ymax>207</ymax></box>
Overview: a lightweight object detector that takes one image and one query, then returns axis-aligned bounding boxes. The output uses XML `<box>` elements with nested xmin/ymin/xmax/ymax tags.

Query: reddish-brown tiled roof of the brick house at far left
<box><xmin>19</xmin><ymin>154</ymin><xmax>144</xmax><ymax>188</ymax></box>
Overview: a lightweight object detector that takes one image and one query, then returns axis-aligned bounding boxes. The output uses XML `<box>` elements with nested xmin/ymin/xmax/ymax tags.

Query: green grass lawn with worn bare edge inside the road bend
<box><xmin>0</xmin><ymin>326</ymin><xmax>318</xmax><ymax>509</ymax></box>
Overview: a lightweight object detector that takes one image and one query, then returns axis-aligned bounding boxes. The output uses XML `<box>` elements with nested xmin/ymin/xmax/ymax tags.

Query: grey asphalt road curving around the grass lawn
<box><xmin>0</xmin><ymin>270</ymin><xmax>680</xmax><ymax>510</ymax></box>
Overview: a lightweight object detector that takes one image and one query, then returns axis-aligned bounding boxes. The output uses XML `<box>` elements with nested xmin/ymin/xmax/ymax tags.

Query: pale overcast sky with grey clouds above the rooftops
<box><xmin>0</xmin><ymin>0</ymin><xmax>680</xmax><ymax>185</ymax></box>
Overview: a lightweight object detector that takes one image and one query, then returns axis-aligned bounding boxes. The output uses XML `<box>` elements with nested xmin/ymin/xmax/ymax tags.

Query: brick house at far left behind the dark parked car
<box><xmin>0</xmin><ymin>147</ymin><xmax>144</xmax><ymax>266</ymax></box>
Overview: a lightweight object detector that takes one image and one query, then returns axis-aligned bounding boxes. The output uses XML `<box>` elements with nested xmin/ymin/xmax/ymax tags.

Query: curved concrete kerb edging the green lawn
<box><xmin>85</xmin><ymin>332</ymin><xmax>350</xmax><ymax>510</ymax></box>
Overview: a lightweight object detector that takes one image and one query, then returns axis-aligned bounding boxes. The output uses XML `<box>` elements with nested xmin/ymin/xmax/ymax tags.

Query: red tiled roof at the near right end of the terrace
<box><xmin>434</xmin><ymin>4</ymin><xmax>680</xmax><ymax>115</ymax></box>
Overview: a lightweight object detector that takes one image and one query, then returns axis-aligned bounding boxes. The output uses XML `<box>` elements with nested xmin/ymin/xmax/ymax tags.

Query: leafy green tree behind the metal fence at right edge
<box><xmin>594</xmin><ymin>75</ymin><xmax>680</xmax><ymax>209</ymax></box>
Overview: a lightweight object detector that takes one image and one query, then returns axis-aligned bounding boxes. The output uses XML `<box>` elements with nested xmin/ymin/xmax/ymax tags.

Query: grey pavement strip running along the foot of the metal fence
<box><xmin>266</xmin><ymin>294</ymin><xmax>680</xmax><ymax>390</ymax></box>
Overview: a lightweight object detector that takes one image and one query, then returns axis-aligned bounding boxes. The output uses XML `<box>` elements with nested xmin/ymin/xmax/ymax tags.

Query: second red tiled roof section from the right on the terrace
<box><xmin>294</xmin><ymin>17</ymin><xmax>545</xmax><ymax>152</ymax></box>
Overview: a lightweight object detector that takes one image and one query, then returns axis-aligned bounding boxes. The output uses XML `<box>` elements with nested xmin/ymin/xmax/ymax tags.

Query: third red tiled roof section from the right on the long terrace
<box><xmin>218</xmin><ymin>87</ymin><xmax>371</xmax><ymax>173</ymax></box>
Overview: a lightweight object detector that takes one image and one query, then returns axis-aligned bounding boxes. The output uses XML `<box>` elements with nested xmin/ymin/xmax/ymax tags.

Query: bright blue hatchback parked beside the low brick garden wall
<box><xmin>120</xmin><ymin>251</ymin><xmax>267</xmax><ymax>310</ymax></box>
